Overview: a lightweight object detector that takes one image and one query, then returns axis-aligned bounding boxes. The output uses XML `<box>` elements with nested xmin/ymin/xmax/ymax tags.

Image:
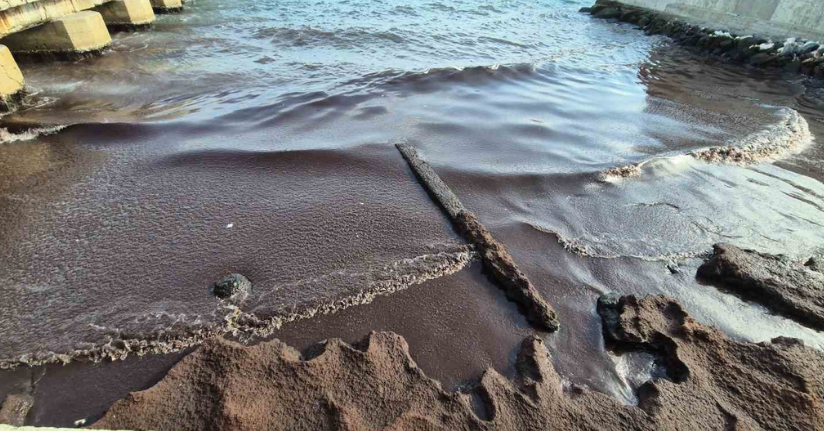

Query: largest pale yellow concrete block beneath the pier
<box><xmin>3</xmin><ymin>11</ymin><xmax>112</xmax><ymax>56</ymax></box>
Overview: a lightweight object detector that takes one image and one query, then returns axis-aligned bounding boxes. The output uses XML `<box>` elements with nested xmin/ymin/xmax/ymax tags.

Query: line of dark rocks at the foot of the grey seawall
<box><xmin>580</xmin><ymin>0</ymin><xmax>824</xmax><ymax>78</ymax></box>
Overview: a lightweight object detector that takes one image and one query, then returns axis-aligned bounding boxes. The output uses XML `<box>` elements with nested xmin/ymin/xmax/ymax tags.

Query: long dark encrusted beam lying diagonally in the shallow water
<box><xmin>397</xmin><ymin>144</ymin><xmax>560</xmax><ymax>332</ymax></box>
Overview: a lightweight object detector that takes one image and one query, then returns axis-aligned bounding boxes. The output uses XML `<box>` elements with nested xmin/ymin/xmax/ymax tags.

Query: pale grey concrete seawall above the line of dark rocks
<box><xmin>622</xmin><ymin>0</ymin><xmax>824</xmax><ymax>40</ymax></box>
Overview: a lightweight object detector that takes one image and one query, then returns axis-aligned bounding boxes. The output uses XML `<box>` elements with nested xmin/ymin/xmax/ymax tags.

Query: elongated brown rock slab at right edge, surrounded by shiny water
<box><xmin>698</xmin><ymin>244</ymin><xmax>824</xmax><ymax>330</ymax></box>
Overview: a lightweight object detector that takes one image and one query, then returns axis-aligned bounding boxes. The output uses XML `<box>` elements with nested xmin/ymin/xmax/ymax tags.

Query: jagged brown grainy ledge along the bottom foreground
<box><xmin>93</xmin><ymin>296</ymin><xmax>824</xmax><ymax>430</ymax></box>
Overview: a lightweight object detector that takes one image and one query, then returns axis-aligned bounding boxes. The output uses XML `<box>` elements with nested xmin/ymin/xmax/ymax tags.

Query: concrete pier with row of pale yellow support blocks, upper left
<box><xmin>0</xmin><ymin>0</ymin><xmax>183</xmax><ymax>112</ymax></box>
